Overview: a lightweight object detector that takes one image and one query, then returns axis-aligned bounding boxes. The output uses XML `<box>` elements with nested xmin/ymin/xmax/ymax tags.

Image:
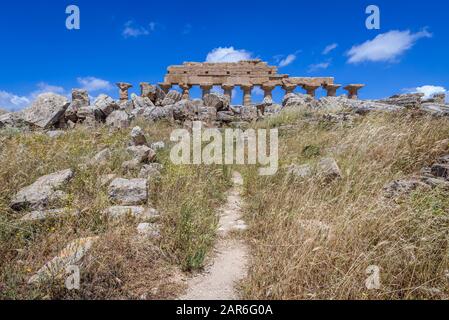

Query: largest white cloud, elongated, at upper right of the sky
<box><xmin>348</xmin><ymin>30</ymin><xmax>432</xmax><ymax>64</ymax></box>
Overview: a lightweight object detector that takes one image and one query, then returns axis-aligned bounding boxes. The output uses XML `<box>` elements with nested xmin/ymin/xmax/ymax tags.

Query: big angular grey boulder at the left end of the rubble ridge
<box><xmin>23</xmin><ymin>93</ymin><xmax>70</xmax><ymax>129</ymax></box>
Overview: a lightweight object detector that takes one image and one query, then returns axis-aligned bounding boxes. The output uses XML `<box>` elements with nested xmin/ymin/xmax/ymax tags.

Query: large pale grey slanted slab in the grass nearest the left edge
<box><xmin>10</xmin><ymin>169</ymin><xmax>73</xmax><ymax>211</ymax></box>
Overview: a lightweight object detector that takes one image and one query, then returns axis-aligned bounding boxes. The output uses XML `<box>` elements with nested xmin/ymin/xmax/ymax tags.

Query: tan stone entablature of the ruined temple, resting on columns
<box><xmin>154</xmin><ymin>60</ymin><xmax>364</xmax><ymax>105</ymax></box>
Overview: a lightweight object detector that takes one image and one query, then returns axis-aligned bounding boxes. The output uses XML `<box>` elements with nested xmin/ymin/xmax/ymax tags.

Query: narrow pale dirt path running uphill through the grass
<box><xmin>180</xmin><ymin>172</ymin><xmax>248</xmax><ymax>300</ymax></box>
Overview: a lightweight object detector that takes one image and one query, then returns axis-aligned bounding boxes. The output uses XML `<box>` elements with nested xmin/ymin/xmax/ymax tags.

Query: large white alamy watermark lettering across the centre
<box><xmin>170</xmin><ymin>122</ymin><xmax>279</xmax><ymax>176</ymax></box>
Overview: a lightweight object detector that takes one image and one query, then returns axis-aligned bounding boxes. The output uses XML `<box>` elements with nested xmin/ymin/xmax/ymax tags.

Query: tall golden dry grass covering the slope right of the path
<box><xmin>243</xmin><ymin>111</ymin><xmax>449</xmax><ymax>299</ymax></box>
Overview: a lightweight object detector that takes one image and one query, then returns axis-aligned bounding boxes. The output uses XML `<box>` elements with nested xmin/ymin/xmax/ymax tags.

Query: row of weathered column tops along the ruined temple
<box><xmin>117</xmin><ymin>82</ymin><xmax>364</xmax><ymax>106</ymax></box>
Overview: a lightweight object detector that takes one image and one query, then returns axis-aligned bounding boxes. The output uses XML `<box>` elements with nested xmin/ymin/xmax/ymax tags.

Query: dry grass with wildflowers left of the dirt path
<box><xmin>0</xmin><ymin>122</ymin><xmax>229</xmax><ymax>299</ymax></box>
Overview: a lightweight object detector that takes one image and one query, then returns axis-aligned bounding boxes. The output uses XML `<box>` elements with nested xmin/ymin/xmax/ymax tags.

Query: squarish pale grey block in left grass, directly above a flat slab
<box><xmin>108</xmin><ymin>178</ymin><xmax>148</xmax><ymax>206</ymax></box>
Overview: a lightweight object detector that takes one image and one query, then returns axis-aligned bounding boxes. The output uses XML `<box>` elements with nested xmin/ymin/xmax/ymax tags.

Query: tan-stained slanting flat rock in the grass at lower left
<box><xmin>28</xmin><ymin>237</ymin><xmax>99</xmax><ymax>284</ymax></box>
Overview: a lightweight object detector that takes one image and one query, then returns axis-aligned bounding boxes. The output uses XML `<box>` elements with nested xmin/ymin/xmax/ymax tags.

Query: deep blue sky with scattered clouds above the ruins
<box><xmin>0</xmin><ymin>0</ymin><xmax>449</xmax><ymax>110</ymax></box>
